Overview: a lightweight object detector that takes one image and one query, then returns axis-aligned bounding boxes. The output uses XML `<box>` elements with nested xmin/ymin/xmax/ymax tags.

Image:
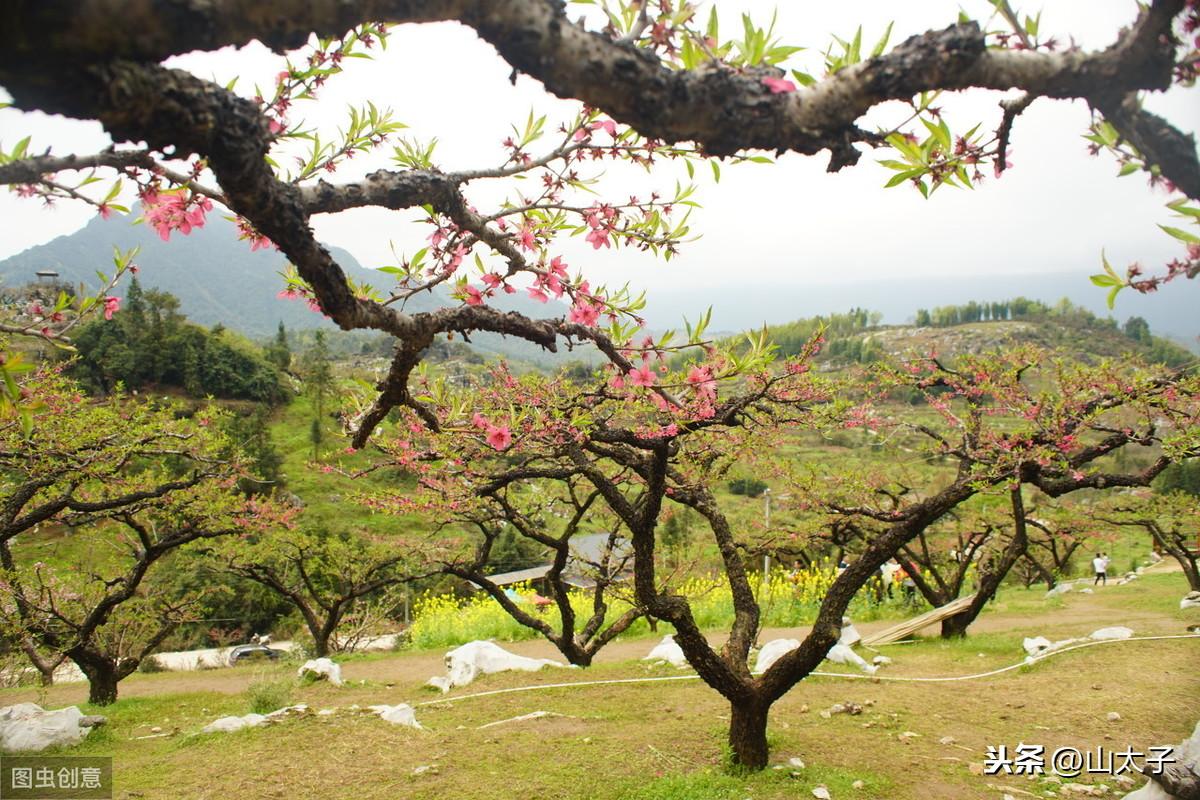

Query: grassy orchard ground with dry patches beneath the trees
<box><xmin>0</xmin><ymin>567</ymin><xmax>1200</xmax><ymax>800</ymax></box>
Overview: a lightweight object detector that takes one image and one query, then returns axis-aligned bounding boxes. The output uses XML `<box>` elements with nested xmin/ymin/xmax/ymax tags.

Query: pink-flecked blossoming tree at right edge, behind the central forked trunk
<box><xmin>794</xmin><ymin>348</ymin><xmax>1200</xmax><ymax>637</ymax></box>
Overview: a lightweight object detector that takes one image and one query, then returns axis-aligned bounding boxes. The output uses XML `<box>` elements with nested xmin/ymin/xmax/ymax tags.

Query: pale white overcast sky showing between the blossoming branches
<box><xmin>0</xmin><ymin>0</ymin><xmax>1200</xmax><ymax>300</ymax></box>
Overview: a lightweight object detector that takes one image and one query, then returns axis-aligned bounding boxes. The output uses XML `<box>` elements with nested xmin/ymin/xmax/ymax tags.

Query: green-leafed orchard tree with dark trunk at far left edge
<box><xmin>0</xmin><ymin>371</ymin><xmax>274</xmax><ymax>704</ymax></box>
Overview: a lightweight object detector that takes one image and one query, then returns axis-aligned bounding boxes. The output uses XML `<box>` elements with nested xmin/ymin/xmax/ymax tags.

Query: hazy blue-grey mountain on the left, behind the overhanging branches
<box><xmin>0</xmin><ymin>212</ymin><xmax>578</xmax><ymax>363</ymax></box>
